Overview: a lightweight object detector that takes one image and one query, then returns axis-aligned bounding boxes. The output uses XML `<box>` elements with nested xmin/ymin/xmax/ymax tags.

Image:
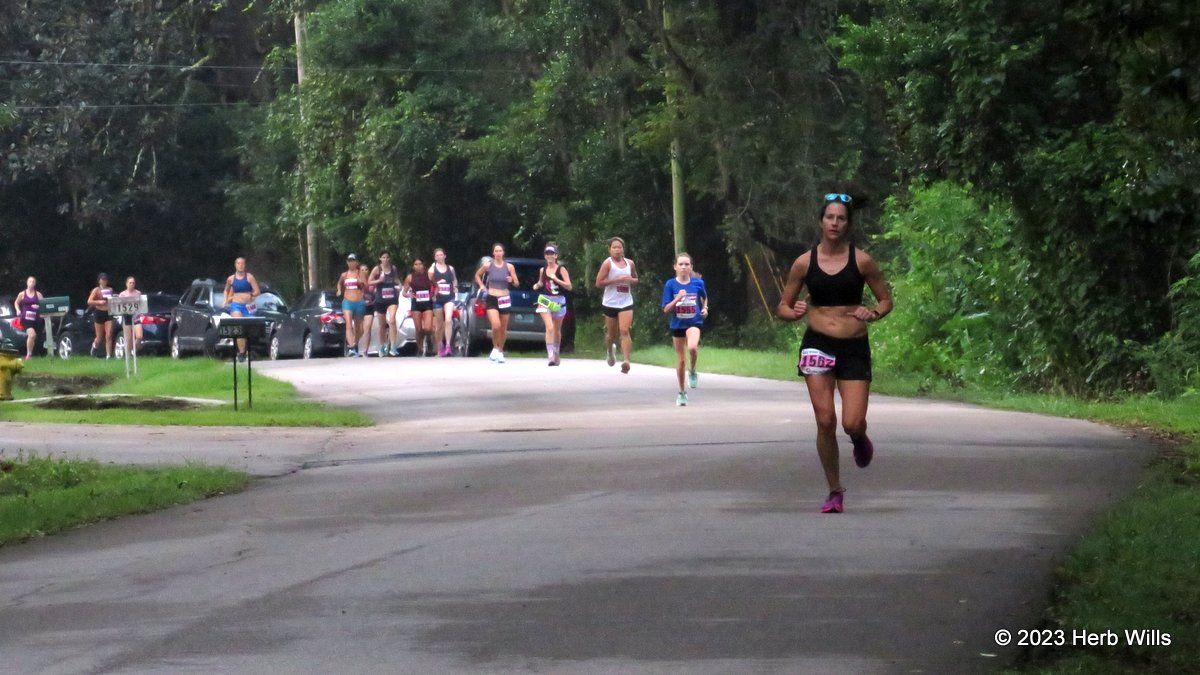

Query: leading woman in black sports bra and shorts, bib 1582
<box><xmin>775</xmin><ymin>193</ymin><xmax>892</xmax><ymax>513</ymax></box>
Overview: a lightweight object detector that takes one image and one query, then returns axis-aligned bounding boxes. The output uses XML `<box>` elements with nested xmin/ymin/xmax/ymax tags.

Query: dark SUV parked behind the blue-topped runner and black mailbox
<box><xmin>167</xmin><ymin>279</ymin><xmax>288</xmax><ymax>359</ymax></box>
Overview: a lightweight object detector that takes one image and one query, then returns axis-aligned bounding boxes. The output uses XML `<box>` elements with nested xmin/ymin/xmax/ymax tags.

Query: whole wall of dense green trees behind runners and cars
<box><xmin>0</xmin><ymin>0</ymin><xmax>1200</xmax><ymax>395</ymax></box>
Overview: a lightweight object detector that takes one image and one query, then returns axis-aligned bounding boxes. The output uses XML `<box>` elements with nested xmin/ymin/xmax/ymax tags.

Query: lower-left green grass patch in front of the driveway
<box><xmin>0</xmin><ymin>458</ymin><xmax>250</xmax><ymax>546</ymax></box>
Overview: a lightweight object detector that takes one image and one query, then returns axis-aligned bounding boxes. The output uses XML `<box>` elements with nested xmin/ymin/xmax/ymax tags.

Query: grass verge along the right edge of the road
<box><xmin>590</xmin><ymin>345</ymin><xmax>1200</xmax><ymax>673</ymax></box>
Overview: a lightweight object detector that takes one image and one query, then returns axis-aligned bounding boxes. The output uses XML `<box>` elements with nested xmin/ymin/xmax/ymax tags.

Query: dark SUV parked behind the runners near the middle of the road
<box><xmin>463</xmin><ymin>257</ymin><xmax>584</xmax><ymax>356</ymax></box>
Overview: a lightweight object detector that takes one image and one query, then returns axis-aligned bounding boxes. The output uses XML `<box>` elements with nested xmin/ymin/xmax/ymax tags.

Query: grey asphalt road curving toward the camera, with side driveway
<box><xmin>0</xmin><ymin>358</ymin><xmax>1151</xmax><ymax>673</ymax></box>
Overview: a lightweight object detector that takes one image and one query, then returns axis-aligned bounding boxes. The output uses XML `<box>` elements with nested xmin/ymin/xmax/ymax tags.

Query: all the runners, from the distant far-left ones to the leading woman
<box><xmin>13</xmin><ymin>193</ymin><xmax>893</xmax><ymax>513</ymax></box>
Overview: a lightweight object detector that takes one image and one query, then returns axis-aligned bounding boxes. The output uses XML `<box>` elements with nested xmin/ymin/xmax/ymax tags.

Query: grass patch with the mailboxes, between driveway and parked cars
<box><xmin>0</xmin><ymin>358</ymin><xmax>372</xmax><ymax>426</ymax></box>
